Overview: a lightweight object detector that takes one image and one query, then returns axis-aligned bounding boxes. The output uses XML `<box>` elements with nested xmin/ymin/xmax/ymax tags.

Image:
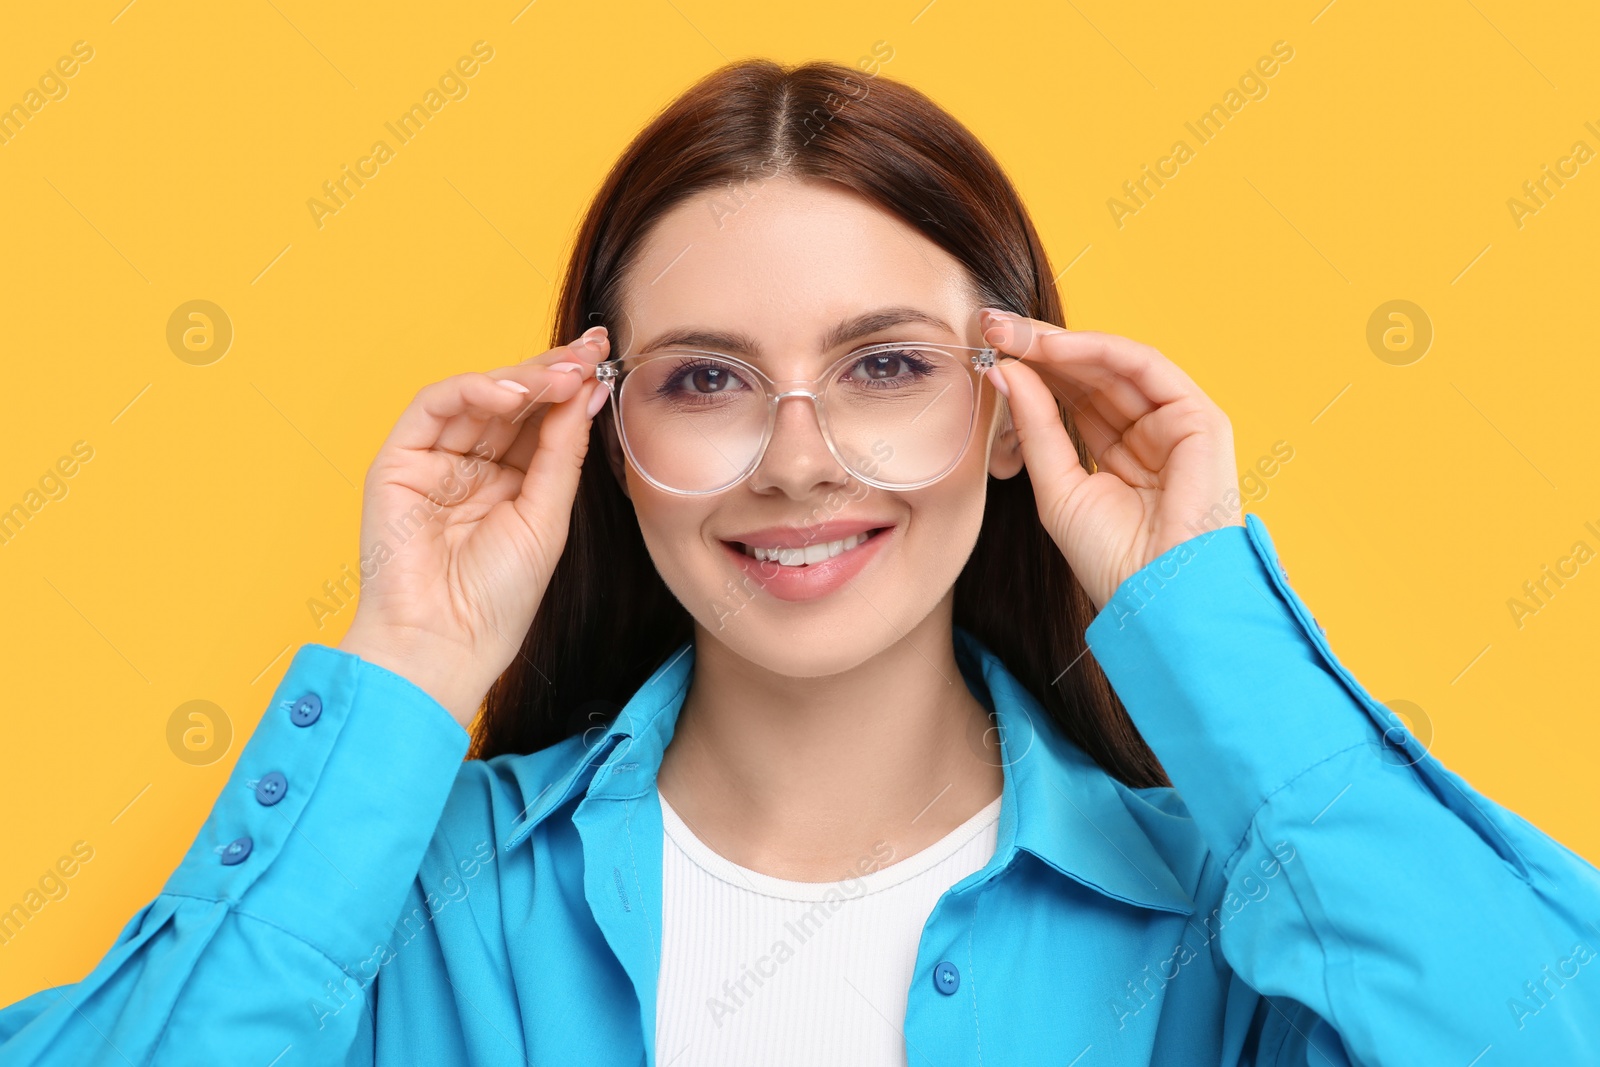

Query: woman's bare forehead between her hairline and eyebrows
<box><xmin>622</xmin><ymin>178</ymin><xmax>976</xmax><ymax>350</ymax></box>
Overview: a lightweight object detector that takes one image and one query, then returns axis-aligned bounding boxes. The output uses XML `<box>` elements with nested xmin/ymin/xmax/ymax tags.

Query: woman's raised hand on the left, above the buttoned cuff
<box><xmin>339</xmin><ymin>326</ymin><xmax>608</xmax><ymax>726</ymax></box>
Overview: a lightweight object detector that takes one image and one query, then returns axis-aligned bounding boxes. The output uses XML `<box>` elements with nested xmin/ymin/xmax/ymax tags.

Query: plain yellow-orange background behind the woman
<box><xmin>0</xmin><ymin>0</ymin><xmax>1600</xmax><ymax>1003</ymax></box>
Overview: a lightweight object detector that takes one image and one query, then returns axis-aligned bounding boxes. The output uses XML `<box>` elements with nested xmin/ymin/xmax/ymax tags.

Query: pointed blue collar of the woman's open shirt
<box><xmin>502</xmin><ymin>627</ymin><xmax>1195</xmax><ymax>915</ymax></box>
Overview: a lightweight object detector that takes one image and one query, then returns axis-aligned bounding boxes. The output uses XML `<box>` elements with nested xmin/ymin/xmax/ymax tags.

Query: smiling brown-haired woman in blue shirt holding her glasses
<box><xmin>0</xmin><ymin>61</ymin><xmax>1600</xmax><ymax>1065</ymax></box>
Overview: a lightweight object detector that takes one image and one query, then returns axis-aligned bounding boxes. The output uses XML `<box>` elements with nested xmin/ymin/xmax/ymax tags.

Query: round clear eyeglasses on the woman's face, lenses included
<box><xmin>595</xmin><ymin>341</ymin><xmax>1018</xmax><ymax>496</ymax></box>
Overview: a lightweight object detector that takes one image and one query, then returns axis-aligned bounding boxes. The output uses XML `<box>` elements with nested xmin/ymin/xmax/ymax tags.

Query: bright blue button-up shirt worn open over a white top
<box><xmin>0</xmin><ymin>515</ymin><xmax>1600</xmax><ymax>1067</ymax></box>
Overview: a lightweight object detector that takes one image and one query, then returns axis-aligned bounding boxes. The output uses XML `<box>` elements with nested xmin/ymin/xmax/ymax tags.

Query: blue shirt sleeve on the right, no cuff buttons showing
<box><xmin>1086</xmin><ymin>515</ymin><xmax>1600</xmax><ymax>1067</ymax></box>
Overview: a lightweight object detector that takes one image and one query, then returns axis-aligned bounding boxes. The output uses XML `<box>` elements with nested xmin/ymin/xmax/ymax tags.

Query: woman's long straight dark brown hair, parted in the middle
<box><xmin>472</xmin><ymin>59</ymin><xmax>1170</xmax><ymax>789</ymax></box>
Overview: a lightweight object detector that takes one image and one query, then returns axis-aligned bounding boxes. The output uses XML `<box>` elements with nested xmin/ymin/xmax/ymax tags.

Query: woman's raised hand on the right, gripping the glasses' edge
<box><xmin>981</xmin><ymin>309</ymin><xmax>1243</xmax><ymax>609</ymax></box>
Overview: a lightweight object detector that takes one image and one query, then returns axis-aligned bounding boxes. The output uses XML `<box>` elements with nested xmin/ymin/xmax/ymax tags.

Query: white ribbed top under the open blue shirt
<box><xmin>656</xmin><ymin>790</ymin><xmax>1000</xmax><ymax>1067</ymax></box>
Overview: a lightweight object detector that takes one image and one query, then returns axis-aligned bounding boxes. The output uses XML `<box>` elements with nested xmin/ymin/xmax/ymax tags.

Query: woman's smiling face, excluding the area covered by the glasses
<box><xmin>613</xmin><ymin>178</ymin><xmax>1021</xmax><ymax>677</ymax></box>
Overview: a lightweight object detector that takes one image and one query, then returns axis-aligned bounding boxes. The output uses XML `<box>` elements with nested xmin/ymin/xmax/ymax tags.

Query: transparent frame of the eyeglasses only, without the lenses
<box><xmin>595</xmin><ymin>341</ymin><xmax>1021</xmax><ymax>496</ymax></box>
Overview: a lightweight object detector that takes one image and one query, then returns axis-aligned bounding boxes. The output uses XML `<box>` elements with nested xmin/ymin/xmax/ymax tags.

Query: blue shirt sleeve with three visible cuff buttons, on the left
<box><xmin>0</xmin><ymin>645</ymin><xmax>469</xmax><ymax>1067</ymax></box>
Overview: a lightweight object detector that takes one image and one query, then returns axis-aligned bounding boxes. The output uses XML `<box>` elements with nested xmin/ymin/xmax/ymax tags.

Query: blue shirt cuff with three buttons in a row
<box><xmin>163</xmin><ymin>645</ymin><xmax>470</xmax><ymax>965</ymax></box>
